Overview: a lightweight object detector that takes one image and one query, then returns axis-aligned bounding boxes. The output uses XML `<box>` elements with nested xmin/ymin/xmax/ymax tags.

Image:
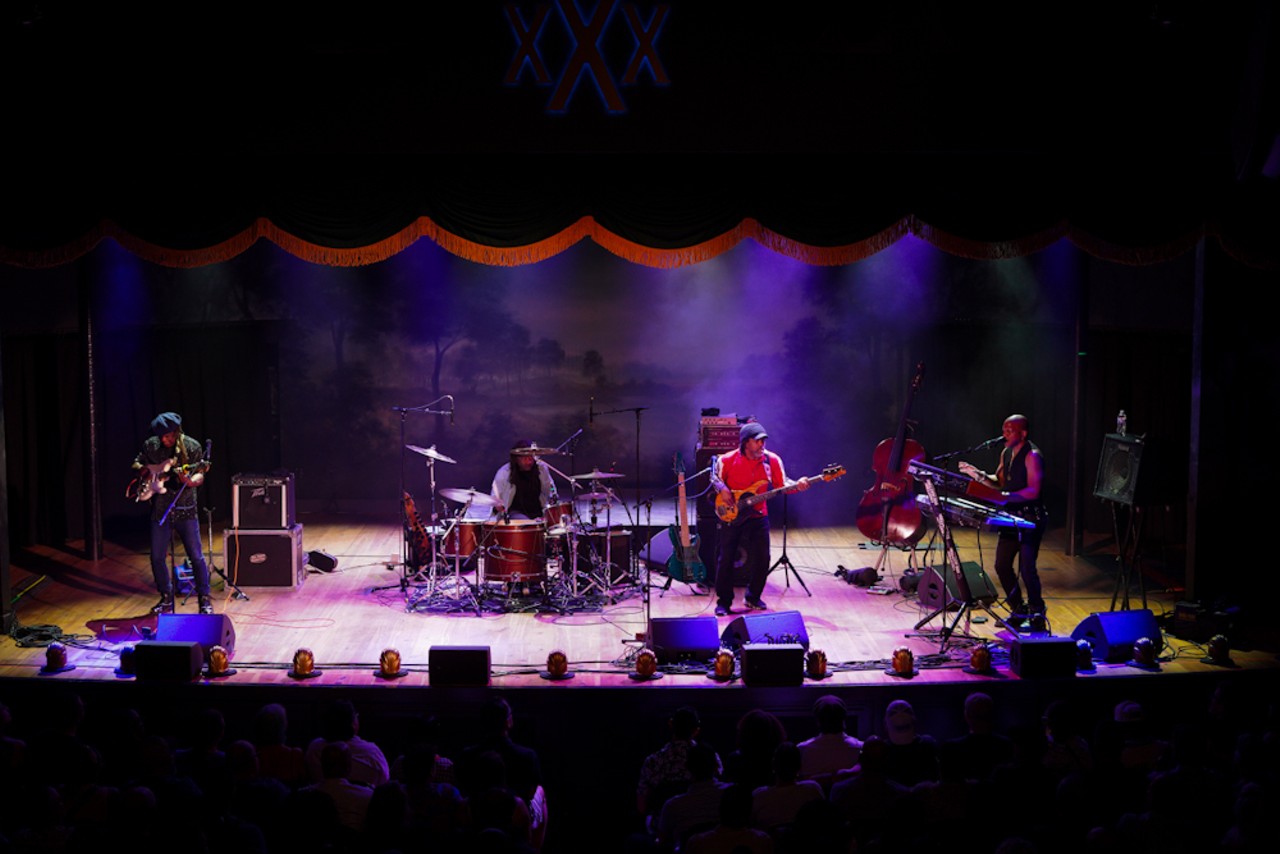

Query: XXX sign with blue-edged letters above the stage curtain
<box><xmin>503</xmin><ymin>0</ymin><xmax>671</xmax><ymax>114</ymax></box>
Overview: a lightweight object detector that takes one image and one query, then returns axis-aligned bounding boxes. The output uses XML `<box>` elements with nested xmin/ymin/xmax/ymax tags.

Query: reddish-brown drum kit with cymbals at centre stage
<box><xmin>406</xmin><ymin>444</ymin><xmax>636</xmax><ymax>615</ymax></box>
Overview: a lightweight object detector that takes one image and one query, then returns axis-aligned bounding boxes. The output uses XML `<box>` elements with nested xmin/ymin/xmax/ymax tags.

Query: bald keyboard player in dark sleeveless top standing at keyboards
<box><xmin>959</xmin><ymin>415</ymin><xmax>1046</xmax><ymax>624</ymax></box>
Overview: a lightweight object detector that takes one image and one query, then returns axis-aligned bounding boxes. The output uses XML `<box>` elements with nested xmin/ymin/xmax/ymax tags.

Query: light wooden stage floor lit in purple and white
<box><xmin>0</xmin><ymin>513</ymin><xmax>1276</xmax><ymax>688</ymax></box>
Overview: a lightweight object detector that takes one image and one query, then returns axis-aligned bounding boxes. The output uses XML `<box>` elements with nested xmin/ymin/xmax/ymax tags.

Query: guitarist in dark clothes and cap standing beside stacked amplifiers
<box><xmin>133</xmin><ymin>412</ymin><xmax>214</xmax><ymax>613</ymax></box>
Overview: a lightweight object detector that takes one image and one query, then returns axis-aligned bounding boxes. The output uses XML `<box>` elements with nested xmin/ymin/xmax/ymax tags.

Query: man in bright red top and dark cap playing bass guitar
<box><xmin>712</xmin><ymin>421</ymin><xmax>809</xmax><ymax>617</ymax></box>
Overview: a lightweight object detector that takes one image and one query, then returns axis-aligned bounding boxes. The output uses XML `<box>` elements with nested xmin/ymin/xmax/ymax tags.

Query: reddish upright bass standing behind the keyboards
<box><xmin>858</xmin><ymin>362</ymin><xmax>925</xmax><ymax>545</ymax></box>
